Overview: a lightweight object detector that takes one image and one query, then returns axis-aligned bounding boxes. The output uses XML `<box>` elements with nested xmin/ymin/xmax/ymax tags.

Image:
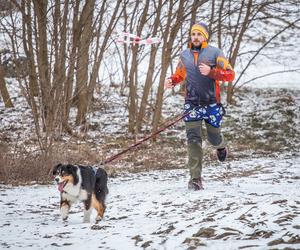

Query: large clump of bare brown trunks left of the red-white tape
<box><xmin>3</xmin><ymin>0</ymin><xmax>121</xmax><ymax>152</ymax></box>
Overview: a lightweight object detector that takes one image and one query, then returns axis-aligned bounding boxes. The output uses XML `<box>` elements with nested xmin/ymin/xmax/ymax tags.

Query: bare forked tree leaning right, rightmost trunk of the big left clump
<box><xmin>76</xmin><ymin>0</ymin><xmax>121</xmax><ymax>125</ymax></box>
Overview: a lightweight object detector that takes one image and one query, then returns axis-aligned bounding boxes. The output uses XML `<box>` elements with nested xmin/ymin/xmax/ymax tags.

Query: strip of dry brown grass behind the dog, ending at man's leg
<box><xmin>0</xmin><ymin>138</ymin><xmax>185</xmax><ymax>185</ymax></box>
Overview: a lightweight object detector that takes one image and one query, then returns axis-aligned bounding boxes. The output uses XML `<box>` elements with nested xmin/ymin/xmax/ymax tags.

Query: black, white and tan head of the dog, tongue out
<box><xmin>52</xmin><ymin>164</ymin><xmax>78</xmax><ymax>192</ymax></box>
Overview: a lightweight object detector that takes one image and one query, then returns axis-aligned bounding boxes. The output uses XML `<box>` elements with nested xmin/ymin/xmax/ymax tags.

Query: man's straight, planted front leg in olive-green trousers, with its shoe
<box><xmin>185</xmin><ymin>121</ymin><xmax>203</xmax><ymax>190</ymax></box>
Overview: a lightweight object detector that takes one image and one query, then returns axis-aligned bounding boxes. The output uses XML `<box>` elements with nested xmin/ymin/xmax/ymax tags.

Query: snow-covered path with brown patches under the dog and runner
<box><xmin>0</xmin><ymin>156</ymin><xmax>300</xmax><ymax>250</ymax></box>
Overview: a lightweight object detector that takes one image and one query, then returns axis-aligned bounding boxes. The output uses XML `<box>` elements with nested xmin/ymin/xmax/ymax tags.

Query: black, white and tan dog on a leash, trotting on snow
<box><xmin>53</xmin><ymin>164</ymin><xmax>108</xmax><ymax>223</ymax></box>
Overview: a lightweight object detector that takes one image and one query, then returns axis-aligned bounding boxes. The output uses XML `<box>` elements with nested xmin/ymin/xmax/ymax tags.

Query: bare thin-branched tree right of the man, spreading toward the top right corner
<box><xmin>211</xmin><ymin>0</ymin><xmax>299</xmax><ymax>103</ymax></box>
